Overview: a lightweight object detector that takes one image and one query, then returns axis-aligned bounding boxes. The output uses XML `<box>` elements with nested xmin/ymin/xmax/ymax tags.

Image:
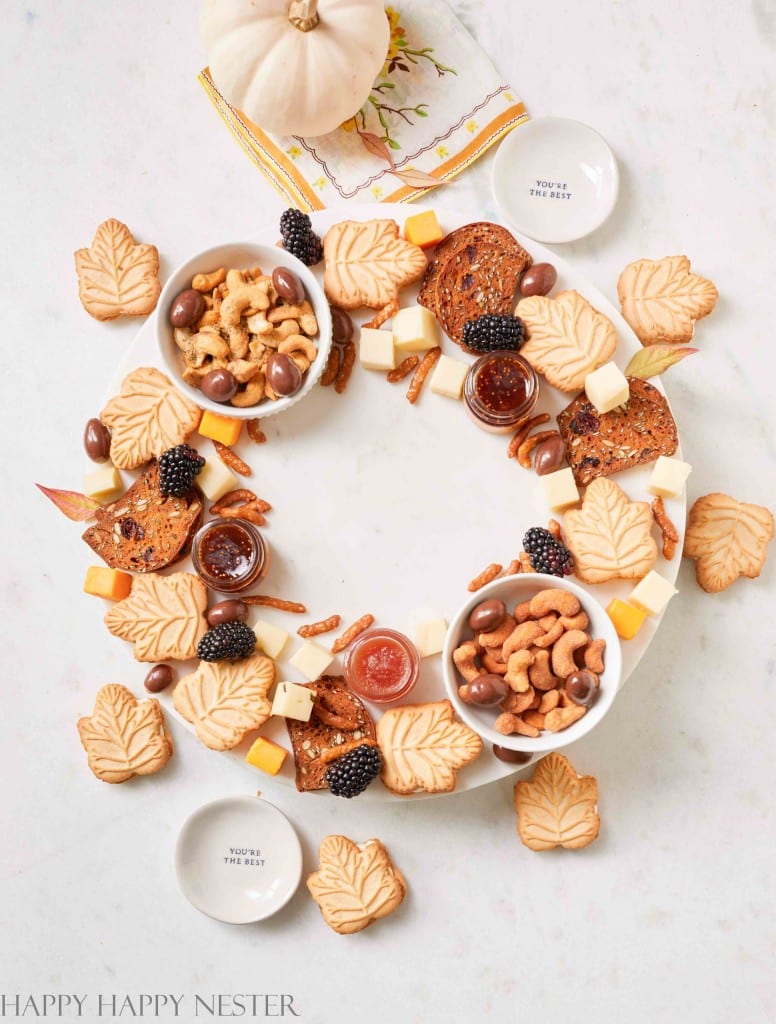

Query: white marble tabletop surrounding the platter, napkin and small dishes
<box><xmin>0</xmin><ymin>0</ymin><xmax>776</xmax><ymax>1024</ymax></box>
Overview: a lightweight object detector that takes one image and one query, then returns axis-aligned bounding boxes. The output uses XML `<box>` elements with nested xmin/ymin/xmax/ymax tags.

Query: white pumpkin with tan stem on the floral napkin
<box><xmin>201</xmin><ymin>0</ymin><xmax>390</xmax><ymax>136</ymax></box>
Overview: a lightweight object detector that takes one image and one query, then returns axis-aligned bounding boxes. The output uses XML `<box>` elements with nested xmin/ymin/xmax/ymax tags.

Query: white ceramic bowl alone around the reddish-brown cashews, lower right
<box><xmin>442</xmin><ymin>572</ymin><xmax>622</xmax><ymax>754</ymax></box>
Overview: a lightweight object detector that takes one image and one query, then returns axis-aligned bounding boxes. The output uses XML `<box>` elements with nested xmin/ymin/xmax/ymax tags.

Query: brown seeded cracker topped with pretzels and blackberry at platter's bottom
<box><xmin>286</xmin><ymin>676</ymin><xmax>375</xmax><ymax>793</ymax></box>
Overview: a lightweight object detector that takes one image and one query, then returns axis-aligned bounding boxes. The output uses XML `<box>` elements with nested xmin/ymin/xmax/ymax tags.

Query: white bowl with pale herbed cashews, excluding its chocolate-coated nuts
<box><xmin>155</xmin><ymin>242</ymin><xmax>332</xmax><ymax>420</ymax></box>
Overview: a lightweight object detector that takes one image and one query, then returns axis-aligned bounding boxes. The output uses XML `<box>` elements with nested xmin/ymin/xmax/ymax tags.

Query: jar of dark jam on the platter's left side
<box><xmin>191</xmin><ymin>518</ymin><xmax>269</xmax><ymax>594</ymax></box>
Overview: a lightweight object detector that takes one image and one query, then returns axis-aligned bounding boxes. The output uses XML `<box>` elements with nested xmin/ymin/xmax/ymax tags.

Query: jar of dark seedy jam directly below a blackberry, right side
<box><xmin>464</xmin><ymin>350</ymin><xmax>538</xmax><ymax>434</ymax></box>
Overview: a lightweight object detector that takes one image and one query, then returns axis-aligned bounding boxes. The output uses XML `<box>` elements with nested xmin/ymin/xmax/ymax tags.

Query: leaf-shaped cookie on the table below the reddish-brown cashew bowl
<box><xmin>515</xmin><ymin>754</ymin><xmax>601</xmax><ymax>850</ymax></box>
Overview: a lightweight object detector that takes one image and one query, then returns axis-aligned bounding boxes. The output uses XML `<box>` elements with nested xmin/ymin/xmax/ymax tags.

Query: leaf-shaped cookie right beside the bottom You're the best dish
<box><xmin>307</xmin><ymin>836</ymin><xmax>406</xmax><ymax>935</ymax></box>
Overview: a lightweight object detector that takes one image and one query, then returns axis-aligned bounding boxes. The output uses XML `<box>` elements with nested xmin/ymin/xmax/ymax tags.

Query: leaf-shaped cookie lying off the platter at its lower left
<box><xmin>78</xmin><ymin>683</ymin><xmax>172</xmax><ymax>782</ymax></box>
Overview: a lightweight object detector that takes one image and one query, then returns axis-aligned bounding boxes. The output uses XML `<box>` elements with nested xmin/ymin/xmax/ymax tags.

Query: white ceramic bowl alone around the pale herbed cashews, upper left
<box><xmin>155</xmin><ymin>242</ymin><xmax>332</xmax><ymax>420</ymax></box>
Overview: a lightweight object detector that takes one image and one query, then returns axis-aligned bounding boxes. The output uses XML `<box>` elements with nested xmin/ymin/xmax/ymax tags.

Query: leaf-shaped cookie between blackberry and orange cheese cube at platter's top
<box><xmin>324</xmin><ymin>220</ymin><xmax>427</xmax><ymax>327</ymax></box>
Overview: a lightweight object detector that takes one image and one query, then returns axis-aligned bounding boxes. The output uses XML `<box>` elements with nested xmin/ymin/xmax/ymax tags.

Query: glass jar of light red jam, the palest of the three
<box><xmin>344</xmin><ymin>629</ymin><xmax>421</xmax><ymax>703</ymax></box>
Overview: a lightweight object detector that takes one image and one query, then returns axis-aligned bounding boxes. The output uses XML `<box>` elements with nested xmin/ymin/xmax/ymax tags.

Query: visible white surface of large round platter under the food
<box><xmin>98</xmin><ymin>202</ymin><xmax>686</xmax><ymax>801</ymax></box>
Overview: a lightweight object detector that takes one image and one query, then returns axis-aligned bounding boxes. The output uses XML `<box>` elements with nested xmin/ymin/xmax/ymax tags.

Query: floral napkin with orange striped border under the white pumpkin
<box><xmin>200</xmin><ymin>0</ymin><xmax>528</xmax><ymax>210</ymax></box>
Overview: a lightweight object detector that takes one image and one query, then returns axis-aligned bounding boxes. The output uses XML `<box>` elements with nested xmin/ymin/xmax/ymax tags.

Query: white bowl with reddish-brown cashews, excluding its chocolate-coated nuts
<box><xmin>442</xmin><ymin>572</ymin><xmax>622</xmax><ymax>754</ymax></box>
